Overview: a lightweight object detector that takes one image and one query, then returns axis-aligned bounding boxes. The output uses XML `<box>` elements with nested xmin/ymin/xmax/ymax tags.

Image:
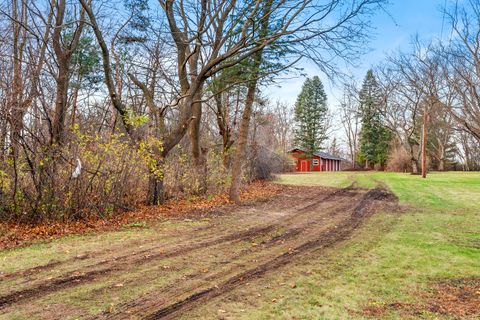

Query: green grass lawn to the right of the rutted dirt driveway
<box><xmin>227</xmin><ymin>172</ymin><xmax>480</xmax><ymax>319</ymax></box>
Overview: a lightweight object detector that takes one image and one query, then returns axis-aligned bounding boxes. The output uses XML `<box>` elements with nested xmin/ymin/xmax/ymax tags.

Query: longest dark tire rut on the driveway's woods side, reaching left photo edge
<box><xmin>0</xmin><ymin>187</ymin><xmax>352</xmax><ymax>310</ymax></box>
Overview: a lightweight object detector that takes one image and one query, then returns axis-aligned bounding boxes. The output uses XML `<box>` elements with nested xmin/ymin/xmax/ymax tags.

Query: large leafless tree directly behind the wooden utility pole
<box><xmin>379</xmin><ymin>38</ymin><xmax>453</xmax><ymax>176</ymax></box>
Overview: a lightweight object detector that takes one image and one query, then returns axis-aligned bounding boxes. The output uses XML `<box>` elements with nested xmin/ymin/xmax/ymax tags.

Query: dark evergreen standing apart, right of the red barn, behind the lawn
<box><xmin>359</xmin><ymin>70</ymin><xmax>391</xmax><ymax>168</ymax></box>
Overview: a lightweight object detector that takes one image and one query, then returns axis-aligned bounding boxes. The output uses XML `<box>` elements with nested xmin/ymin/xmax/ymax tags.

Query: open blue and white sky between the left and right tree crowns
<box><xmin>264</xmin><ymin>0</ymin><xmax>455</xmax><ymax>109</ymax></box>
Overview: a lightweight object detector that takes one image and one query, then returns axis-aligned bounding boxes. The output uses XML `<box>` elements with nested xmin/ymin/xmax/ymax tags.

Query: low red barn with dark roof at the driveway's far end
<box><xmin>289</xmin><ymin>149</ymin><xmax>342</xmax><ymax>172</ymax></box>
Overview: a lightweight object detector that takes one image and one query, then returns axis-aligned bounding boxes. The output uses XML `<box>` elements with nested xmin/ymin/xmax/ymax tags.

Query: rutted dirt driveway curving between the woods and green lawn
<box><xmin>0</xmin><ymin>186</ymin><xmax>396</xmax><ymax>319</ymax></box>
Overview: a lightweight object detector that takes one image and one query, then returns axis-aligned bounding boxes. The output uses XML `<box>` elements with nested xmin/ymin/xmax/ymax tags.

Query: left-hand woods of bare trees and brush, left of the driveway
<box><xmin>0</xmin><ymin>0</ymin><xmax>385</xmax><ymax>221</ymax></box>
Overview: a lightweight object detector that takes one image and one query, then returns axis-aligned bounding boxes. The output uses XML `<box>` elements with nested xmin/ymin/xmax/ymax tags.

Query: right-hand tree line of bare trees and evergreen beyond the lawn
<box><xmin>340</xmin><ymin>0</ymin><xmax>480</xmax><ymax>174</ymax></box>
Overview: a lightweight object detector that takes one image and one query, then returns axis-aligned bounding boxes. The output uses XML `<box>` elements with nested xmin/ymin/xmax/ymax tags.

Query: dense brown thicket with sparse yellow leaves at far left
<box><xmin>0</xmin><ymin>128</ymin><xmax>148</xmax><ymax>222</ymax></box>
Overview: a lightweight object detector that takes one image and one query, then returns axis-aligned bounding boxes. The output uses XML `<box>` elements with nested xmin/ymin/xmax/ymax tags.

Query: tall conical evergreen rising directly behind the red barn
<box><xmin>295</xmin><ymin>76</ymin><xmax>328</xmax><ymax>156</ymax></box>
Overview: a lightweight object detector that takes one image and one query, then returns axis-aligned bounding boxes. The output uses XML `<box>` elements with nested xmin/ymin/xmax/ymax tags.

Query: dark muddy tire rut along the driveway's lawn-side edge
<box><xmin>106</xmin><ymin>189</ymin><xmax>396</xmax><ymax>319</ymax></box>
